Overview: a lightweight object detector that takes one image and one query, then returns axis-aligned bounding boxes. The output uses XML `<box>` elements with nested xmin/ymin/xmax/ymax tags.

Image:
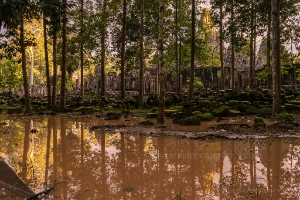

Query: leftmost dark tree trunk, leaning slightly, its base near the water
<box><xmin>20</xmin><ymin>16</ymin><xmax>32</xmax><ymax>114</ymax></box>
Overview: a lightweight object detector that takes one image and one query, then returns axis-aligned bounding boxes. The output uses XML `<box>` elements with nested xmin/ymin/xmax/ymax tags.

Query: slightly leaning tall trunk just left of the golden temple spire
<box><xmin>187</xmin><ymin>0</ymin><xmax>196</xmax><ymax>101</ymax></box>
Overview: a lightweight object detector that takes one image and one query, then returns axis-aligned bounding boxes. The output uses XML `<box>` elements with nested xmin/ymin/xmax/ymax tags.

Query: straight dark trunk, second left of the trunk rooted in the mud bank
<box><xmin>121</xmin><ymin>0</ymin><xmax>127</xmax><ymax>100</ymax></box>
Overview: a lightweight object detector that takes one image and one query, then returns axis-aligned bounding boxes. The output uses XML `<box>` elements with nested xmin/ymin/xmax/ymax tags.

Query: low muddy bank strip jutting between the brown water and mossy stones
<box><xmin>90</xmin><ymin>116</ymin><xmax>300</xmax><ymax>140</ymax></box>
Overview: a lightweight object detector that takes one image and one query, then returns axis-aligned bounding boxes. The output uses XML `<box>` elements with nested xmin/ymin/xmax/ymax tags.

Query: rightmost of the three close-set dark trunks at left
<box><xmin>60</xmin><ymin>0</ymin><xmax>67</xmax><ymax>110</ymax></box>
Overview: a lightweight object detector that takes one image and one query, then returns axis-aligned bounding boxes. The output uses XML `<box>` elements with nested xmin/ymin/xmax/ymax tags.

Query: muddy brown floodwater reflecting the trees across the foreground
<box><xmin>0</xmin><ymin>116</ymin><xmax>300</xmax><ymax>200</ymax></box>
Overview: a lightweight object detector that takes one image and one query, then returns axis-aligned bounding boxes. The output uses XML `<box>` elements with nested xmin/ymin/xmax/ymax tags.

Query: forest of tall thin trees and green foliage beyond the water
<box><xmin>0</xmin><ymin>0</ymin><xmax>300</xmax><ymax>124</ymax></box>
